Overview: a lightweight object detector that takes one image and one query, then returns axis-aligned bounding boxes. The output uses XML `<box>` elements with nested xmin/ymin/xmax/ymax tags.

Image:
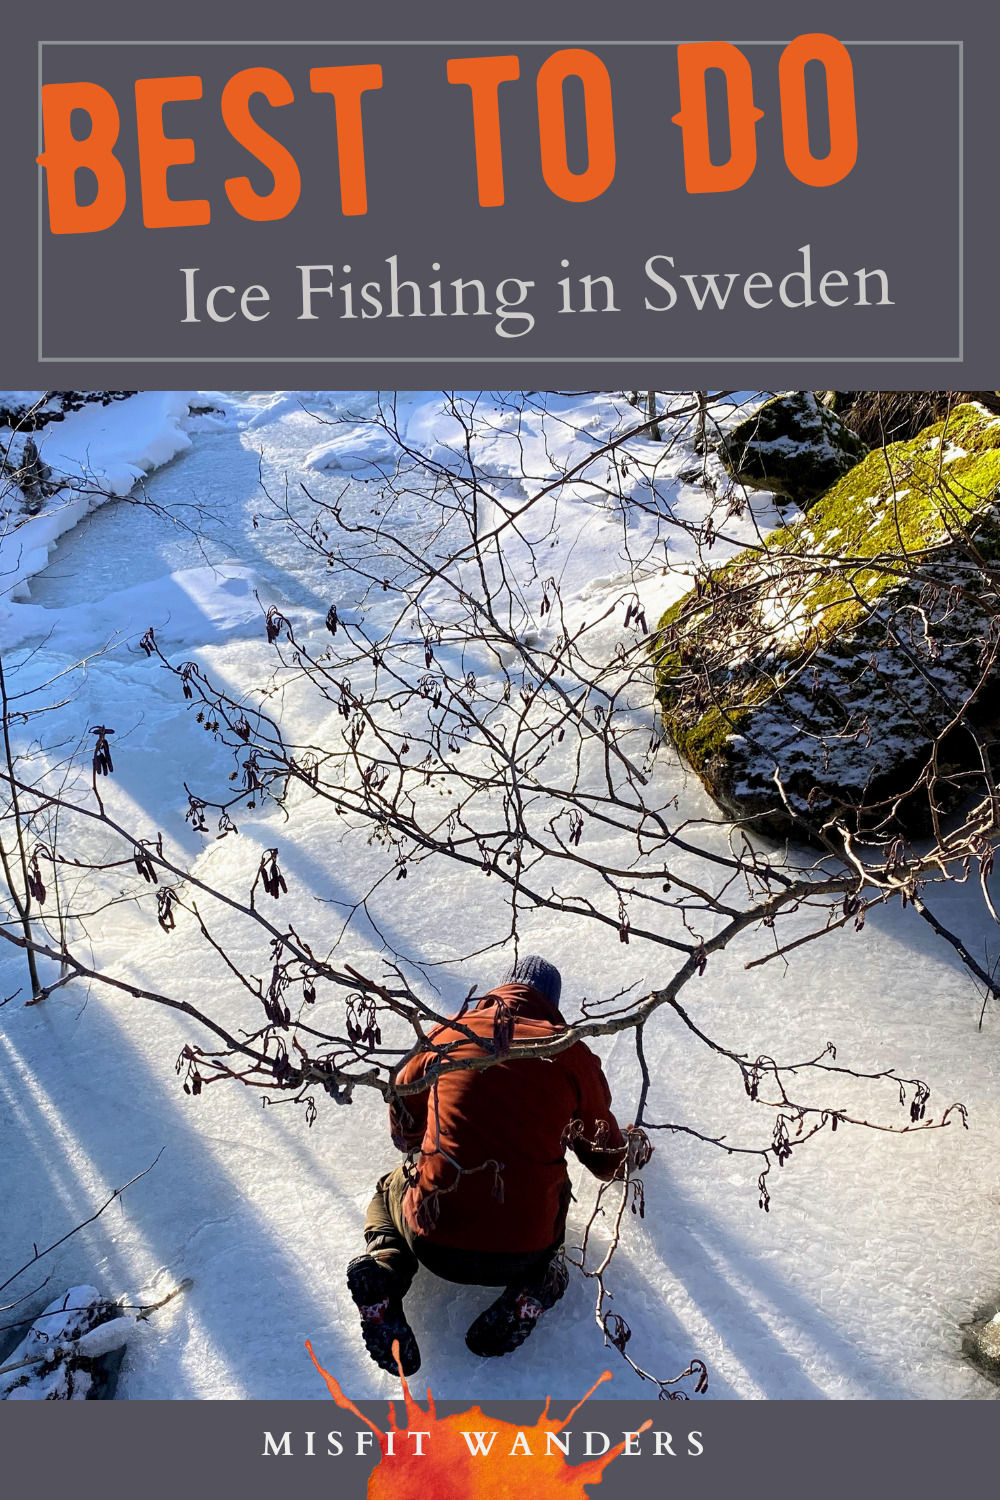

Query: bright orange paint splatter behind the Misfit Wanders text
<box><xmin>306</xmin><ymin>1341</ymin><xmax>652</xmax><ymax>1500</ymax></box>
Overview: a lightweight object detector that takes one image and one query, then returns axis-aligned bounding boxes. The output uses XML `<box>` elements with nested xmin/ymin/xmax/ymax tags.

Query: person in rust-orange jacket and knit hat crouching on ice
<box><xmin>348</xmin><ymin>954</ymin><xmax>638</xmax><ymax>1376</ymax></box>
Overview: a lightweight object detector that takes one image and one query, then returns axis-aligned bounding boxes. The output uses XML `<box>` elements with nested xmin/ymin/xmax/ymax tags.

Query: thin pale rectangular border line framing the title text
<box><xmin>37</xmin><ymin>38</ymin><xmax>966</xmax><ymax>365</ymax></box>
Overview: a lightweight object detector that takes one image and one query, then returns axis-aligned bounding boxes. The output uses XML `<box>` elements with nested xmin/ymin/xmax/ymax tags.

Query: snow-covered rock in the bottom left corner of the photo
<box><xmin>0</xmin><ymin>1286</ymin><xmax>135</xmax><ymax>1401</ymax></box>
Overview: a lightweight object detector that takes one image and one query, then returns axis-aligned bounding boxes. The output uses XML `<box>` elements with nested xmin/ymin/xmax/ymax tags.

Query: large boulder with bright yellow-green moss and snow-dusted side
<box><xmin>652</xmin><ymin>404</ymin><xmax>1000</xmax><ymax>837</ymax></box>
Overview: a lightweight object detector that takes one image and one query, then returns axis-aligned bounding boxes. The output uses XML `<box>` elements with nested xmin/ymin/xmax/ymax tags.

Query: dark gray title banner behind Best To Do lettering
<box><xmin>3</xmin><ymin>0</ymin><xmax>1000</xmax><ymax>389</ymax></box>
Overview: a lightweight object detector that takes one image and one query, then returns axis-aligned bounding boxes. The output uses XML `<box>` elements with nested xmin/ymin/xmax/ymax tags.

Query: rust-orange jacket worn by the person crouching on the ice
<box><xmin>390</xmin><ymin>984</ymin><xmax>624</xmax><ymax>1253</ymax></box>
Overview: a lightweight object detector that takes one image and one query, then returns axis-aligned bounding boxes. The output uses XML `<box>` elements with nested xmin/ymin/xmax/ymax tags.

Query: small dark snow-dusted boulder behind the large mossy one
<box><xmin>720</xmin><ymin>390</ymin><xmax>868</xmax><ymax>510</ymax></box>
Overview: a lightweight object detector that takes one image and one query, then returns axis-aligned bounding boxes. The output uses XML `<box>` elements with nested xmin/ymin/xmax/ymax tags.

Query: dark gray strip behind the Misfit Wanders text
<box><xmin>0</xmin><ymin>1401</ymin><xmax>996</xmax><ymax>1500</ymax></box>
